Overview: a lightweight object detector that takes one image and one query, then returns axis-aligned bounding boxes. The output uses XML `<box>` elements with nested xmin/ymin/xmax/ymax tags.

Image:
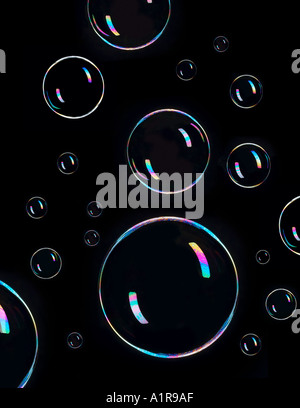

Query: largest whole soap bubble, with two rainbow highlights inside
<box><xmin>99</xmin><ymin>217</ymin><xmax>238</xmax><ymax>358</ymax></box>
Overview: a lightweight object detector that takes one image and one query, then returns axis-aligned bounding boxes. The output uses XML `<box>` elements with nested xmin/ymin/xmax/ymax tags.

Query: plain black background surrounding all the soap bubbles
<box><xmin>0</xmin><ymin>0</ymin><xmax>300</xmax><ymax>404</ymax></box>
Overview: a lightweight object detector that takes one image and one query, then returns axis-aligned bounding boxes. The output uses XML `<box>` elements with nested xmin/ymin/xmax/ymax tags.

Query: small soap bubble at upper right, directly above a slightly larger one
<box><xmin>230</xmin><ymin>75</ymin><xmax>263</xmax><ymax>109</ymax></box>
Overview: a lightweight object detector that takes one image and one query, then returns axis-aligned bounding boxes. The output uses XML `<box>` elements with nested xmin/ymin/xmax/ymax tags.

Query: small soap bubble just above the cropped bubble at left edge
<box><xmin>30</xmin><ymin>248</ymin><xmax>62</xmax><ymax>279</ymax></box>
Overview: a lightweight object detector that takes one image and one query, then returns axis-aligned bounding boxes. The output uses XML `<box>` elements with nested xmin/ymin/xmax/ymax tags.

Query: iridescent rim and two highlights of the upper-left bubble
<box><xmin>42</xmin><ymin>55</ymin><xmax>105</xmax><ymax>119</ymax></box>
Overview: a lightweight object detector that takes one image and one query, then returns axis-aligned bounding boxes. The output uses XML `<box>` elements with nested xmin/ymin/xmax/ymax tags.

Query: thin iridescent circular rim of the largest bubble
<box><xmin>98</xmin><ymin>216</ymin><xmax>239</xmax><ymax>359</ymax></box>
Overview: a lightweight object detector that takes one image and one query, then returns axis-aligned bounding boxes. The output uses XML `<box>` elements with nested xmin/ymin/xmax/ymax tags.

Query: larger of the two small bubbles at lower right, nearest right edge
<box><xmin>265</xmin><ymin>288</ymin><xmax>297</xmax><ymax>320</ymax></box>
